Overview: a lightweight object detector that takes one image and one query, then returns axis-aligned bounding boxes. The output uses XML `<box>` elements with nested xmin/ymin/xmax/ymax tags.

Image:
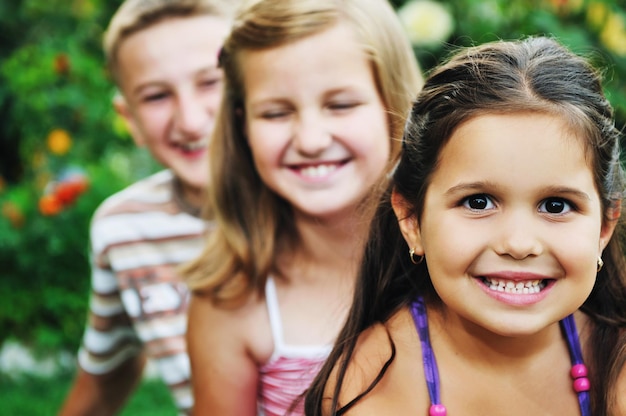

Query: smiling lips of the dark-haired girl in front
<box><xmin>474</xmin><ymin>272</ymin><xmax>556</xmax><ymax>306</ymax></box>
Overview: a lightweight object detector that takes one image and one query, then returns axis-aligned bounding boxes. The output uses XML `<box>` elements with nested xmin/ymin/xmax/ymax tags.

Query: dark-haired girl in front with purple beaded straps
<box><xmin>306</xmin><ymin>37</ymin><xmax>626</xmax><ymax>416</ymax></box>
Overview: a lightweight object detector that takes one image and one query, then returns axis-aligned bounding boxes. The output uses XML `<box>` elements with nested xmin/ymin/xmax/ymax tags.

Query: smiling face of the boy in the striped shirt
<box><xmin>116</xmin><ymin>16</ymin><xmax>230</xmax><ymax>202</ymax></box>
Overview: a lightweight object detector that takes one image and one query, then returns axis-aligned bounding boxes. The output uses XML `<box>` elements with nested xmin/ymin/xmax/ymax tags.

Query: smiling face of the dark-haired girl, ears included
<box><xmin>394</xmin><ymin>113</ymin><xmax>614</xmax><ymax>336</ymax></box>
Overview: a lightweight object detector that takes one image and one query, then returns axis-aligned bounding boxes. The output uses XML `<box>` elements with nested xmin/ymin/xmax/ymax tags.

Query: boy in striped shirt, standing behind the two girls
<box><xmin>61</xmin><ymin>0</ymin><xmax>234</xmax><ymax>415</ymax></box>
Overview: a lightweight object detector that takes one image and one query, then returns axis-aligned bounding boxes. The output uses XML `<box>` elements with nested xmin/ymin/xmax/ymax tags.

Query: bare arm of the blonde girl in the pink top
<box><xmin>187</xmin><ymin>295</ymin><xmax>259</xmax><ymax>416</ymax></box>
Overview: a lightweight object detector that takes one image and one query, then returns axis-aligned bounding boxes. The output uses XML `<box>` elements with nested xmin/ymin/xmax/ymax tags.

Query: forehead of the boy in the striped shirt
<box><xmin>118</xmin><ymin>15</ymin><xmax>230</xmax><ymax>89</ymax></box>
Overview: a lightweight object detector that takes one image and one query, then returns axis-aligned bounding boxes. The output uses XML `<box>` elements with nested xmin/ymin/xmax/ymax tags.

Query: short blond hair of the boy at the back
<box><xmin>103</xmin><ymin>0</ymin><xmax>239</xmax><ymax>86</ymax></box>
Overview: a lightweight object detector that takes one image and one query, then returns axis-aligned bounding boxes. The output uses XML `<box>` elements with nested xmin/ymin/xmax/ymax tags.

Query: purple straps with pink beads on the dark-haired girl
<box><xmin>411</xmin><ymin>297</ymin><xmax>591</xmax><ymax>416</ymax></box>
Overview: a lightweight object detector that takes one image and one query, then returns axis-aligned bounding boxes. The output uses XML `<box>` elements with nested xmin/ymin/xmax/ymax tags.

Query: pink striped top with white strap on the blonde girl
<box><xmin>258</xmin><ymin>278</ymin><xmax>332</xmax><ymax>416</ymax></box>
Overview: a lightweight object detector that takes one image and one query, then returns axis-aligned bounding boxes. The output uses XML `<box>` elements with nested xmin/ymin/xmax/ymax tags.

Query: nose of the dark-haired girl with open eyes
<box><xmin>494</xmin><ymin>210</ymin><xmax>543</xmax><ymax>260</ymax></box>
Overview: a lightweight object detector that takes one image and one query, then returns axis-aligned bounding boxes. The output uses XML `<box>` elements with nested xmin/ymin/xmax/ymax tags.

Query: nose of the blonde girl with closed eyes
<box><xmin>293</xmin><ymin>111</ymin><xmax>332</xmax><ymax>156</ymax></box>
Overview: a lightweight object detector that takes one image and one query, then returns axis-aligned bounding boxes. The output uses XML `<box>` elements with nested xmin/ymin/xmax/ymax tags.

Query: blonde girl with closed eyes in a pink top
<box><xmin>180</xmin><ymin>0</ymin><xmax>421</xmax><ymax>416</ymax></box>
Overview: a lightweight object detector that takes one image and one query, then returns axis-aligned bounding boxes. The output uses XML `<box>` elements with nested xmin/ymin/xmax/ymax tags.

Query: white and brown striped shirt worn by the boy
<box><xmin>78</xmin><ymin>170</ymin><xmax>207</xmax><ymax>414</ymax></box>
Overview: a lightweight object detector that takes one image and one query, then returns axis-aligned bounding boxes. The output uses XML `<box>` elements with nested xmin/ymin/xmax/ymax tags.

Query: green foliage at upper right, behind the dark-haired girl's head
<box><xmin>394</xmin><ymin>0</ymin><xmax>626</xmax><ymax>126</ymax></box>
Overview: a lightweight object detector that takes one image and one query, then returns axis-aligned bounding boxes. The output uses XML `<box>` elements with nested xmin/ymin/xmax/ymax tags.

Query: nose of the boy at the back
<box><xmin>174</xmin><ymin>92</ymin><xmax>213</xmax><ymax>139</ymax></box>
